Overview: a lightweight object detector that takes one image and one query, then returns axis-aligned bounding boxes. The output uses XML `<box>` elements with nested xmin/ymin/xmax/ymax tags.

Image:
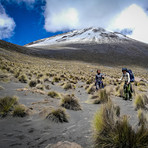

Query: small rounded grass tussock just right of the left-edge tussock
<box><xmin>13</xmin><ymin>104</ymin><xmax>27</xmax><ymax>117</ymax></box>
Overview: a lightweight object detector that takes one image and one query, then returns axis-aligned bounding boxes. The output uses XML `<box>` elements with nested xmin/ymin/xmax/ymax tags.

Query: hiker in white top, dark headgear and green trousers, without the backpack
<box><xmin>119</xmin><ymin>68</ymin><xmax>132</xmax><ymax>100</ymax></box>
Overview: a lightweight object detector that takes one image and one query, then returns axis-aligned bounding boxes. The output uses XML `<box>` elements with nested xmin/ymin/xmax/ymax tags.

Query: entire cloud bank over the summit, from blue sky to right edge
<box><xmin>44</xmin><ymin>0</ymin><xmax>148</xmax><ymax>43</ymax></box>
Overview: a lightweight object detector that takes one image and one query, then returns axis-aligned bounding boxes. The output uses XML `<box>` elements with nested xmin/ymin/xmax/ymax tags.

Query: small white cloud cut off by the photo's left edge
<box><xmin>0</xmin><ymin>4</ymin><xmax>15</xmax><ymax>39</ymax></box>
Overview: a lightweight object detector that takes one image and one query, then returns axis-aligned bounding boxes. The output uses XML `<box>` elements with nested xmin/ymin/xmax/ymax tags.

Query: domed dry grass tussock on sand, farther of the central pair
<box><xmin>60</xmin><ymin>95</ymin><xmax>81</xmax><ymax>111</ymax></box>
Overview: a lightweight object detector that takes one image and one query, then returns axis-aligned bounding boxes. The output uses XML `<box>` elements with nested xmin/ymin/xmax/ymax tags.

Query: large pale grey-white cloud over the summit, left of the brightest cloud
<box><xmin>44</xmin><ymin>0</ymin><xmax>128</xmax><ymax>32</ymax></box>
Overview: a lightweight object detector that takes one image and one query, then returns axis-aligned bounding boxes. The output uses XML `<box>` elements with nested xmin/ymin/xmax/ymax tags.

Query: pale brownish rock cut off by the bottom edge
<box><xmin>45</xmin><ymin>141</ymin><xmax>82</xmax><ymax>148</ymax></box>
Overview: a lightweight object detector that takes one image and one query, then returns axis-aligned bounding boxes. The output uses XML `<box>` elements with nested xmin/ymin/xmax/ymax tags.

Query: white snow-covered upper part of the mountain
<box><xmin>25</xmin><ymin>27</ymin><xmax>131</xmax><ymax>47</ymax></box>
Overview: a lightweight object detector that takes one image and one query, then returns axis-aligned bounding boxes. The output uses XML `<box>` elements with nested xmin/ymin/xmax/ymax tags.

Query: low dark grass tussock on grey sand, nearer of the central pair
<box><xmin>46</xmin><ymin>108</ymin><xmax>68</xmax><ymax>123</ymax></box>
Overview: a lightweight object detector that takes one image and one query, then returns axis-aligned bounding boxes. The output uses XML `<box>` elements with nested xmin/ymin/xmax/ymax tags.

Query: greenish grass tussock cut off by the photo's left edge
<box><xmin>0</xmin><ymin>97</ymin><xmax>18</xmax><ymax>117</ymax></box>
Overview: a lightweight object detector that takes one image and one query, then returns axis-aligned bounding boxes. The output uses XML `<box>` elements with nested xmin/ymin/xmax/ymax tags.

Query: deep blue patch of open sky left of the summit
<box><xmin>2</xmin><ymin>2</ymin><xmax>65</xmax><ymax>45</ymax></box>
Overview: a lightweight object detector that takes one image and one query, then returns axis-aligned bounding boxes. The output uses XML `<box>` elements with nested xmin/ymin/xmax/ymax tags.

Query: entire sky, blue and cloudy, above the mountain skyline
<box><xmin>0</xmin><ymin>0</ymin><xmax>148</xmax><ymax>45</ymax></box>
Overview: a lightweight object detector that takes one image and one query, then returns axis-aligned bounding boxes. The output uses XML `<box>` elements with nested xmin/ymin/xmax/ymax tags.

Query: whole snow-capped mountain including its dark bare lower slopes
<box><xmin>25</xmin><ymin>28</ymin><xmax>148</xmax><ymax>67</ymax></box>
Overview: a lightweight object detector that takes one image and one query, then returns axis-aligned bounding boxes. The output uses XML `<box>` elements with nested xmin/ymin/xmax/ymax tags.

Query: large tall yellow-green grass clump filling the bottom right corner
<box><xmin>93</xmin><ymin>102</ymin><xmax>148</xmax><ymax>148</ymax></box>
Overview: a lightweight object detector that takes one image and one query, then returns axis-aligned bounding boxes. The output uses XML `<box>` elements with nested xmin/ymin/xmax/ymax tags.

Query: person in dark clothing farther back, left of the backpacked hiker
<box><xmin>95</xmin><ymin>69</ymin><xmax>104</xmax><ymax>90</ymax></box>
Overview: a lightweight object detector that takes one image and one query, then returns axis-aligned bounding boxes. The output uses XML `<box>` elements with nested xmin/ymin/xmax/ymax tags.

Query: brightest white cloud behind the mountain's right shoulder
<box><xmin>109</xmin><ymin>4</ymin><xmax>148</xmax><ymax>43</ymax></box>
